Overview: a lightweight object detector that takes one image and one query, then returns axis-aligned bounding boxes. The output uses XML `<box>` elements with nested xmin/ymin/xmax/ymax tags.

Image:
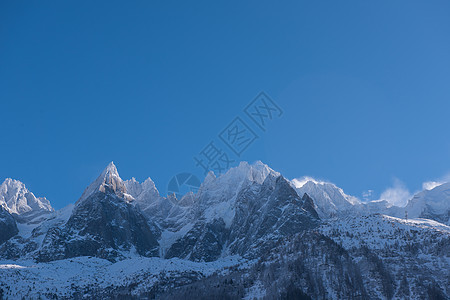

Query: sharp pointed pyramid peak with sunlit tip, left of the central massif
<box><xmin>38</xmin><ymin>164</ymin><xmax>159</xmax><ymax>261</ymax></box>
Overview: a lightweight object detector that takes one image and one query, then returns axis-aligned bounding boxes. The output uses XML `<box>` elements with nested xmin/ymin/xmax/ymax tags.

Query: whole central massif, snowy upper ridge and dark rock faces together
<box><xmin>166</xmin><ymin>165</ymin><xmax>320</xmax><ymax>261</ymax></box>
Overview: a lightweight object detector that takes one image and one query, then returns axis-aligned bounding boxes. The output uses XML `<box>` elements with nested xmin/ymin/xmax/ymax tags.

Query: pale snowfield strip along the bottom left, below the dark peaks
<box><xmin>0</xmin><ymin>256</ymin><xmax>250</xmax><ymax>299</ymax></box>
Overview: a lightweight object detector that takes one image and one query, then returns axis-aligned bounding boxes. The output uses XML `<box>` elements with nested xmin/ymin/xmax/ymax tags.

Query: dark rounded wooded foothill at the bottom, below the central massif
<box><xmin>239</xmin><ymin>231</ymin><xmax>369</xmax><ymax>299</ymax></box>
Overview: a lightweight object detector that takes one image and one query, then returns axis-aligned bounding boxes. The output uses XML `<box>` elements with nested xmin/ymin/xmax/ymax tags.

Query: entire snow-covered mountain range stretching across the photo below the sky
<box><xmin>0</xmin><ymin>162</ymin><xmax>450</xmax><ymax>299</ymax></box>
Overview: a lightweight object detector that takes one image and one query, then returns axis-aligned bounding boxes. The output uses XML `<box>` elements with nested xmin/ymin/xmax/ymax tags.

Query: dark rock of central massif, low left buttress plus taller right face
<box><xmin>166</xmin><ymin>174</ymin><xmax>320</xmax><ymax>261</ymax></box>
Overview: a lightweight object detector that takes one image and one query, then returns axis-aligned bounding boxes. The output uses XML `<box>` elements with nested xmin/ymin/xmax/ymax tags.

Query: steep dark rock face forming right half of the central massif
<box><xmin>229</xmin><ymin>175</ymin><xmax>320</xmax><ymax>258</ymax></box>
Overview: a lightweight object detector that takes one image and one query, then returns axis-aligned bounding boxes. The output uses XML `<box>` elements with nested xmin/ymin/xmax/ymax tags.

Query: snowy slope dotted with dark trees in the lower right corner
<box><xmin>320</xmin><ymin>214</ymin><xmax>450</xmax><ymax>299</ymax></box>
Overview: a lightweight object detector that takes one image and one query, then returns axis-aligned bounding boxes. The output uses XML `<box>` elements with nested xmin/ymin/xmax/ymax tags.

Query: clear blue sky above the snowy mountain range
<box><xmin>0</xmin><ymin>1</ymin><xmax>450</xmax><ymax>208</ymax></box>
